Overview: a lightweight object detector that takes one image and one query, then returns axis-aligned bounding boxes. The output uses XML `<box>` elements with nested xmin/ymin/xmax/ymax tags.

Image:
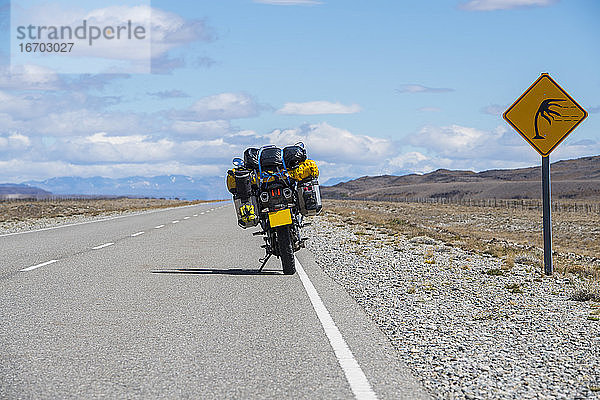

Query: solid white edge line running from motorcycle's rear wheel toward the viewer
<box><xmin>294</xmin><ymin>256</ymin><xmax>377</xmax><ymax>400</ymax></box>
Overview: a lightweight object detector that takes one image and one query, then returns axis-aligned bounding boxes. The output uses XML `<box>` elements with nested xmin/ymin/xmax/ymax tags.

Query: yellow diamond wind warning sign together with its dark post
<box><xmin>502</xmin><ymin>73</ymin><xmax>587</xmax><ymax>275</ymax></box>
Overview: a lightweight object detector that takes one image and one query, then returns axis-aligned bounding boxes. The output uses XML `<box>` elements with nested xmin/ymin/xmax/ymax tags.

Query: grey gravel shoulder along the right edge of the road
<box><xmin>305</xmin><ymin>215</ymin><xmax>600</xmax><ymax>399</ymax></box>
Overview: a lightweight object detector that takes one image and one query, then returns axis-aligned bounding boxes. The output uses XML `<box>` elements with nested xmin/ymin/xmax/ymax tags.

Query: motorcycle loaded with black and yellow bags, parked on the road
<box><xmin>227</xmin><ymin>143</ymin><xmax>322</xmax><ymax>275</ymax></box>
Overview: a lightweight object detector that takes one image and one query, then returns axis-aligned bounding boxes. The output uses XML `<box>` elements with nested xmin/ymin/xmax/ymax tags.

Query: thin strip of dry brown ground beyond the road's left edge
<box><xmin>0</xmin><ymin>198</ymin><xmax>211</xmax><ymax>222</ymax></box>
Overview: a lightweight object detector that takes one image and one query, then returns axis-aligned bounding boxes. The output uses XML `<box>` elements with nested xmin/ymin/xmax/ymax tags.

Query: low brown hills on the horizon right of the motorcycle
<box><xmin>321</xmin><ymin>156</ymin><xmax>600</xmax><ymax>200</ymax></box>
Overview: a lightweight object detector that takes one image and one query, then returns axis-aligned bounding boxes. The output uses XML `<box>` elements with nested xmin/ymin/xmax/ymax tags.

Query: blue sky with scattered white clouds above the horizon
<box><xmin>0</xmin><ymin>0</ymin><xmax>600</xmax><ymax>182</ymax></box>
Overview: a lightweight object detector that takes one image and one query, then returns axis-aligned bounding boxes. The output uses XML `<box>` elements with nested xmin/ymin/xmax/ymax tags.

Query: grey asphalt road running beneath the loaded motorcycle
<box><xmin>0</xmin><ymin>203</ymin><xmax>427</xmax><ymax>399</ymax></box>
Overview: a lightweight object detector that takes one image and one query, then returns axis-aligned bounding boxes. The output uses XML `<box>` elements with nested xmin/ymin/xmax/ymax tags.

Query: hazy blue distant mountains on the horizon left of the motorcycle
<box><xmin>0</xmin><ymin>175</ymin><xmax>230</xmax><ymax>200</ymax></box>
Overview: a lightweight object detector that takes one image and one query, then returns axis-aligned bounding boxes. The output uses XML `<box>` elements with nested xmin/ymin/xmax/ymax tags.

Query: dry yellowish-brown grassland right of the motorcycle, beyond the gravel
<box><xmin>324</xmin><ymin>200</ymin><xmax>600</xmax><ymax>282</ymax></box>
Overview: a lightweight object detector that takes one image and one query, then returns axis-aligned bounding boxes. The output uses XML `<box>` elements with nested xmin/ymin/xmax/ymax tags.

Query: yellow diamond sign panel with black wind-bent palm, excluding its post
<box><xmin>502</xmin><ymin>74</ymin><xmax>587</xmax><ymax>157</ymax></box>
